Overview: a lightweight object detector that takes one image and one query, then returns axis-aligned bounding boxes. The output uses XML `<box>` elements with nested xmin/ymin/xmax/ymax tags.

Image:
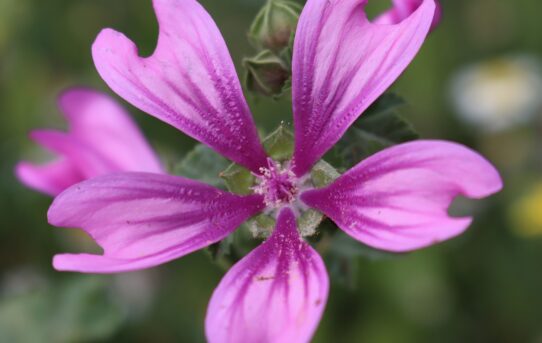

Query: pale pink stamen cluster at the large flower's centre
<box><xmin>252</xmin><ymin>158</ymin><xmax>298</xmax><ymax>208</ymax></box>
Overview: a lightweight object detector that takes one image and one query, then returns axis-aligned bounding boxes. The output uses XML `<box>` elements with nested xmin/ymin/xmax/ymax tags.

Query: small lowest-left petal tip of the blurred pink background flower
<box><xmin>15</xmin><ymin>159</ymin><xmax>84</xmax><ymax>196</ymax></box>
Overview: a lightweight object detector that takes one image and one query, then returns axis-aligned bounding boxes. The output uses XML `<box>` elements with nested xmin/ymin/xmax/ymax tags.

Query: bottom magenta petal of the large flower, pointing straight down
<box><xmin>205</xmin><ymin>209</ymin><xmax>329</xmax><ymax>343</ymax></box>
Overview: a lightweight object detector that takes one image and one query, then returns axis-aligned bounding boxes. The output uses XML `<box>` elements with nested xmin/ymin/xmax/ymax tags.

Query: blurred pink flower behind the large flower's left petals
<box><xmin>15</xmin><ymin>88</ymin><xmax>162</xmax><ymax>196</ymax></box>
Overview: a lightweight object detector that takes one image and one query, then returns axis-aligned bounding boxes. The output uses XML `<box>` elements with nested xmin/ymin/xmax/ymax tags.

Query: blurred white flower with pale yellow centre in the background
<box><xmin>451</xmin><ymin>55</ymin><xmax>542</xmax><ymax>131</ymax></box>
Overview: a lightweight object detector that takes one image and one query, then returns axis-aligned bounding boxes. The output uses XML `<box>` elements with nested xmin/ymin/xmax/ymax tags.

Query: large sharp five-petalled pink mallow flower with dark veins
<box><xmin>48</xmin><ymin>0</ymin><xmax>502</xmax><ymax>342</ymax></box>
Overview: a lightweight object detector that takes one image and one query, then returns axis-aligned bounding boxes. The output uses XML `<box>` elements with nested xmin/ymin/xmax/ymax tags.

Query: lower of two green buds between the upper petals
<box><xmin>243</xmin><ymin>50</ymin><xmax>290</xmax><ymax>96</ymax></box>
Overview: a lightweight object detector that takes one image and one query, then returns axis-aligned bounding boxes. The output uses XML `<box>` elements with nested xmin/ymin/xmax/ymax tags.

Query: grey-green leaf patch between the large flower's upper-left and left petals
<box><xmin>173</xmin><ymin>144</ymin><xmax>230</xmax><ymax>188</ymax></box>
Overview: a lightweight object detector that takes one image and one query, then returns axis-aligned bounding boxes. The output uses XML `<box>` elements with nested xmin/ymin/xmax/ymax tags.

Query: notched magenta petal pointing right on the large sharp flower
<box><xmin>301</xmin><ymin>141</ymin><xmax>502</xmax><ymax>252</ymax></box>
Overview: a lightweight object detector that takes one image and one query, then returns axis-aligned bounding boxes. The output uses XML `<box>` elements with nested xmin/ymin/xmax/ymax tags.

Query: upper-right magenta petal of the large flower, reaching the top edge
<box><xmin>292</xmin><ymin>0</ymin><xmax>435</xmax><ymax>176</ymax></box>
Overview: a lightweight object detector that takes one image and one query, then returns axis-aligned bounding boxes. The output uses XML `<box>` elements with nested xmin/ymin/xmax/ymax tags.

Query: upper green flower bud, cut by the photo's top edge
<box><xmin>248</xmin><ymin>0</ymin><xmax>302</xmax><ymax>52</ymax></box>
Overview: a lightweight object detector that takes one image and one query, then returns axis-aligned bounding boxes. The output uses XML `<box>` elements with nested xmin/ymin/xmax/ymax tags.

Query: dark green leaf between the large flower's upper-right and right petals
<box><xmin>330</xmin><ymin>93</ymin><xmax>419</xmax><ymax>169</ymax></box>
